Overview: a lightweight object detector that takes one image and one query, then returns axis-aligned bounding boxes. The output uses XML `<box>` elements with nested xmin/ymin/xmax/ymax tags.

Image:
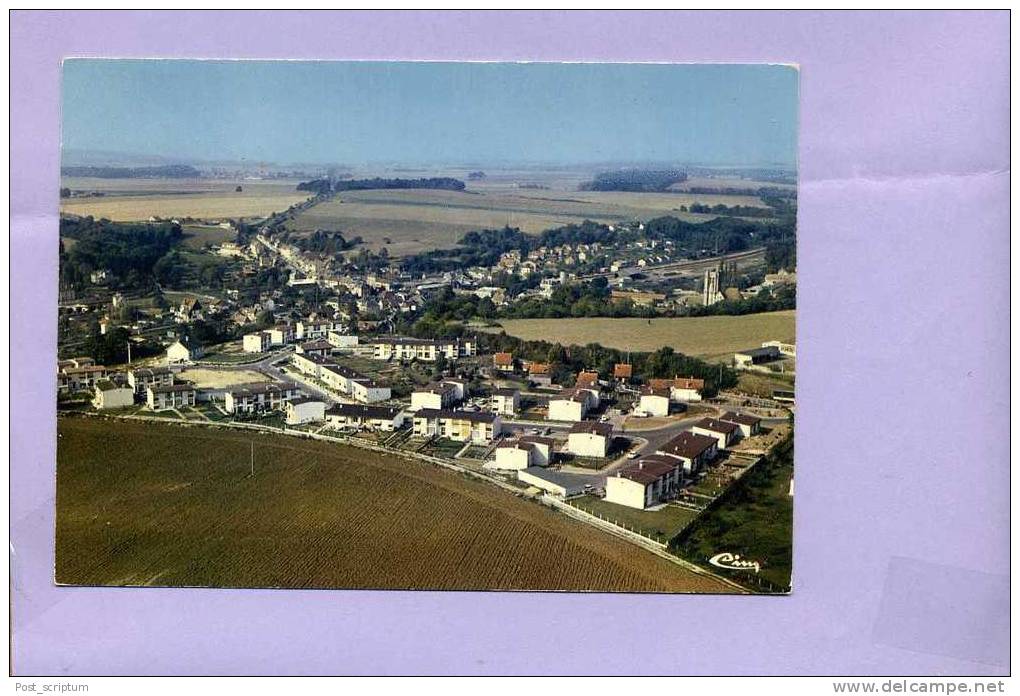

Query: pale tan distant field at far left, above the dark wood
<box><xmin>60</xmin><ymin>178</ymin><xmax>309</xmax><ymax>221</ymax></box>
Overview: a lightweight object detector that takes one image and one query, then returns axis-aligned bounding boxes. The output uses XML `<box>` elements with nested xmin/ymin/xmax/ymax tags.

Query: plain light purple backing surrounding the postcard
<box><xmin>10</xmin><ymin>11</ymin><xmax>1010</xmax><ymax>675</ymax></box>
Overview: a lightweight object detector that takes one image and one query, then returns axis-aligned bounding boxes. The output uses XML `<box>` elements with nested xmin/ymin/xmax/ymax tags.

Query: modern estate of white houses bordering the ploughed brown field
<box><xmin>57</xmin><ymin>302</ymin><xmax>795</xmax><ymax>542</ymax></box>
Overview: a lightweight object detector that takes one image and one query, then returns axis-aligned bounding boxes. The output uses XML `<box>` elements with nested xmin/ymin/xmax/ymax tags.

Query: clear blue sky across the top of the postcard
<box><xmin>62</xmin><ymin>59</ymin><xmax>798</xmax><ymax>166</ymax></box>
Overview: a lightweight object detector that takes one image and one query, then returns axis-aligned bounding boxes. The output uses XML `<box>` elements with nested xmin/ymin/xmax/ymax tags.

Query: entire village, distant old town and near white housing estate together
<box><xmin>57</xmin><ymin>182</ymin><xmax>796</xmax><ymax>563</ymax></box>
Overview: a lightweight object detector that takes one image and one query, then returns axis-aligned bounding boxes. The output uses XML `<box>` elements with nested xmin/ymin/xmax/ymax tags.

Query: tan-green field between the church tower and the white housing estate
<box><xmin>491</xmin><ymin>310</ymin><xmax>796</xmax><ymax>358</ymax></box>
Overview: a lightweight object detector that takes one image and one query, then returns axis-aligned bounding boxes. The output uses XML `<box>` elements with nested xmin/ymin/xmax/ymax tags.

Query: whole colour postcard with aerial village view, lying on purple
<box><xmin>54</xmin><ymin>59</ymin><xmax>799</xmax><ymax>594</ymax></box>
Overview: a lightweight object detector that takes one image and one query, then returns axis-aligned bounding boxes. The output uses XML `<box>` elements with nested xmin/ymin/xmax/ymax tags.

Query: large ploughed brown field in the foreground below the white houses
<box><xmin>56</xmin><ymin>418</ymin><xmax>731</xmax><ymax>592</ymax></box>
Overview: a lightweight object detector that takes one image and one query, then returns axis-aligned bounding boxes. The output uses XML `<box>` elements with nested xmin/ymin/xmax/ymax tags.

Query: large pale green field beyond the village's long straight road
<box><xmin>288</xmin><ymin>186</ymin><xmax>762</xmax><ymax>256</ymax></box>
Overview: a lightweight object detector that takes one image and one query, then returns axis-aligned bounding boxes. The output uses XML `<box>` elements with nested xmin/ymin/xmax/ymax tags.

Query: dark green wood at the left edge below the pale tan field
<box><xmin>60</xmin><ymin>217</ymin><xmax>184</xmax><ymax>287</ymax></box>
